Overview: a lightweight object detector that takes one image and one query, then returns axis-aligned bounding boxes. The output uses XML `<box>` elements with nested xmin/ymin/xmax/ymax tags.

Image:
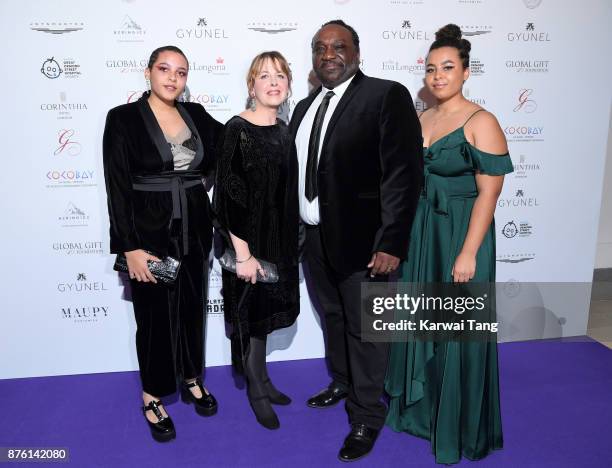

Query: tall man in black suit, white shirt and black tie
<box><xmin>291</xmin><ymin>20</ymin><xmax>423</xmax><ymax>461</ymax></box>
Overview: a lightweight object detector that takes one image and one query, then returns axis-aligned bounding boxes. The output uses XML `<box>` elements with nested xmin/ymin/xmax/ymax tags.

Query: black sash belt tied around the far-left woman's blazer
<box><xmin>132</xmin><ymin>171</ymin><xmax>202</xmax><ymax>255</ymax></box>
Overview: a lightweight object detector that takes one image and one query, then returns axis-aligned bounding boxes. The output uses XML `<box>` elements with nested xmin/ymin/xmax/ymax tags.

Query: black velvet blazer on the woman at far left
<box><xmin>103</xmin><ymin>95</ymin><xmax>223</xmax><ymax>255</ymax></box>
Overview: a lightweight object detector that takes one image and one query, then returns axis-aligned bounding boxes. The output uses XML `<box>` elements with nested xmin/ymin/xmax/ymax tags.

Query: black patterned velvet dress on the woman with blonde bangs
<box><xmin>213</xmin><ymin>116</ymin><xmax>299</xmax><ymax>370</ymax></box>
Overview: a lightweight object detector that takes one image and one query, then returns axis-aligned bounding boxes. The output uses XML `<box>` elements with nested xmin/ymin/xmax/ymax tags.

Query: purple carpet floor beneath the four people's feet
<box><xmin>0</xmin><ymin>341</ymin><xmax>612</xmax><ymax>468</ymax></box>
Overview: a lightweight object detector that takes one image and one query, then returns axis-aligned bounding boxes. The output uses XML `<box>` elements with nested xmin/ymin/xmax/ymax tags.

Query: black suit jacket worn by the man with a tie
<box><xmin>290</xmin><ymin>71</ymin><xmax>423</xmax><ymax>273</ymax></box>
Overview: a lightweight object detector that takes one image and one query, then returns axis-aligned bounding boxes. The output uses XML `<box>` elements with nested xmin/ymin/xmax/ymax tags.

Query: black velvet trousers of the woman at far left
<box><xmin>130</xmin><ymin>236</ymin><xmax>208</xmax><ymax>397</ymax></box>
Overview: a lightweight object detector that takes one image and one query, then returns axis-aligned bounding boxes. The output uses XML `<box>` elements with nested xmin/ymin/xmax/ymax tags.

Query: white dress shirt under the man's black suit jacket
<box><xmin>295</xmin><ymin>75</ymin><xmax>355</xmax><ymax>224</ymax></box>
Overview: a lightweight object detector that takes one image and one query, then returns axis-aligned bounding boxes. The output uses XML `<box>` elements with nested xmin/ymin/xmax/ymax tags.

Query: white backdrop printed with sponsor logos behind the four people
<box><xmin>0</xmin><ymin>0</ymin><xmax>612</xmax><ymax>378</ymax></box>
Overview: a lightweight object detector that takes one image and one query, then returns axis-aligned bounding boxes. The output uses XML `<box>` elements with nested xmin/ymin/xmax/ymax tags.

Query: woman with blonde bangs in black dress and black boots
<box><xmin>214</xmin><ymin>52</ymin><xmax>299</xmax><ymax>429</ymax></box>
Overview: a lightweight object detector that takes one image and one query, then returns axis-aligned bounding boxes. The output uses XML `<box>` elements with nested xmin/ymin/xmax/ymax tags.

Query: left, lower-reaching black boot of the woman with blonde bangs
<box><xmin>244</xmin><ymin>336</ymin><xmax>280</xmax><ymax>429</ymax></box>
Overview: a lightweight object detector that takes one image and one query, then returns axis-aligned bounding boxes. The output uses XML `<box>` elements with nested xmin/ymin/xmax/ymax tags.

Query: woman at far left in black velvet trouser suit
<box><xmin>103</xmin><ymin>46</ymin><xmax>223</xmax><ymax>441</ymax></box>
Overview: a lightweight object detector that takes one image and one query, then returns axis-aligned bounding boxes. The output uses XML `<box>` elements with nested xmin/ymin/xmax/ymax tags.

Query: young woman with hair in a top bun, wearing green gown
<box><xmin>386</xmin><ymin>24</ymin><xmax>512</xmax><ymax>464</ymax></box>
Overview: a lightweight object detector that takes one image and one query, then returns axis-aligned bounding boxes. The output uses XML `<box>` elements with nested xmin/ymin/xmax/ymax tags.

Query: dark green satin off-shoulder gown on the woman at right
<box><xmin>385</xmin><ymin>120</ymin><xmax>512</xmax><ymax>464</ymax></box>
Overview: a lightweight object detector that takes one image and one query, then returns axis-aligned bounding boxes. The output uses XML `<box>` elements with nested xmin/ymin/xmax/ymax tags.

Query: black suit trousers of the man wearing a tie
<box><xmin>304</xmin><ymin>226</ymin><xmax>389</xmax><ymax>429</ymax></box>
